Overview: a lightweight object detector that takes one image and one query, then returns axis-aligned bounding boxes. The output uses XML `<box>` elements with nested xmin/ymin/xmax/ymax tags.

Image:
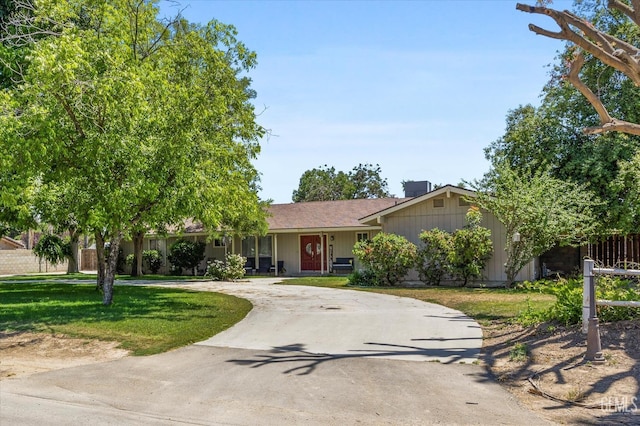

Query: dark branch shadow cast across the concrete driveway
<box><xmin>227</xmin><ymin>339</ymin><xmax>480</xmax><ymax>375</ymax></box>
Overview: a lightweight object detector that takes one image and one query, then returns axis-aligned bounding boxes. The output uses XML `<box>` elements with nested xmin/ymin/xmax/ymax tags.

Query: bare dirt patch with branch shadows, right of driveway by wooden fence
<box><xmin>483</xmin><ymin>321</ymin><xmax>640</xmax><ymax>425</ymax></box>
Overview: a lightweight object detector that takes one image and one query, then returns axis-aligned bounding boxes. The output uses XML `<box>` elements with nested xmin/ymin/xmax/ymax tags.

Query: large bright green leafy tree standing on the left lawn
<box><xmin>0</xmin><ymin>0</ymin><xmax>265</xmax><ymax>304</ymax></box>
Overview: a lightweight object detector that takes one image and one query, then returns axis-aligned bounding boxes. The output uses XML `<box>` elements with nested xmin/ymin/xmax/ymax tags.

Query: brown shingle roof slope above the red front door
<box><xmin>267</xmin><ymin>198</ymin><xmax>405</xmax><ymax>231</ymax></box>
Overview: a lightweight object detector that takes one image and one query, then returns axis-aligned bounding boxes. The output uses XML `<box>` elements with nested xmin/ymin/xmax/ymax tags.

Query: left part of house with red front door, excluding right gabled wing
<box><xmin>122</xmin><ymin>198</ymin><xmax>405</xmax><ymax>275</ymax></box>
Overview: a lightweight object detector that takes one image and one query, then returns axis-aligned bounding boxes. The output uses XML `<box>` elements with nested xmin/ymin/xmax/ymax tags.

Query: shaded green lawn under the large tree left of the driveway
<box><xmin>0</xmin><ymin>282</ymin><xmax>252</xmax><ymax>355</ymax></box>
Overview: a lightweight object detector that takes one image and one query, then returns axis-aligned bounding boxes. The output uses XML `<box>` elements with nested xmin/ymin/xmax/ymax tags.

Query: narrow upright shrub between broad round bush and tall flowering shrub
<box><xmin>416</xmin><ymin>228</ymin><xmax>453</xmax><ymax>285</ymax></box>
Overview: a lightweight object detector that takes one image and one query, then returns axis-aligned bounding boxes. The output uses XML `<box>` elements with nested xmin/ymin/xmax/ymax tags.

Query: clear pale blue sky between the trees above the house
<box><xmin>169</xmin><ymin>0</ymin><xmax>572</xmax><ymax>203</ymax></box>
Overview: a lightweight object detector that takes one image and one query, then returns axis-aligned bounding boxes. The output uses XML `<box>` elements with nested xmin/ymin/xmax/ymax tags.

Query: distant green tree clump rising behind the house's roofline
<box><xmin>292</xmin><ymin>164</ymin><xmax>391</xmax><ymax>203</ymax></box>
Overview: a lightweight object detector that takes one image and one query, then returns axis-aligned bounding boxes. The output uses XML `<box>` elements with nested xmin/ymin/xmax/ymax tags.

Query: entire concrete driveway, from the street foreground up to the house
<box><xmin>0</xmin><ymin>279</ymin><xmax>547</xmax><ymax>425</ymax></box>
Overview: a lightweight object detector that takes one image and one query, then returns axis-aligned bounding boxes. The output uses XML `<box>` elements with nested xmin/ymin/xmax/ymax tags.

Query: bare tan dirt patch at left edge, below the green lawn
<box><xmin>0</xmin><ymin>332</ymin><xmax>129</xmax><ymax>380</ymax></box>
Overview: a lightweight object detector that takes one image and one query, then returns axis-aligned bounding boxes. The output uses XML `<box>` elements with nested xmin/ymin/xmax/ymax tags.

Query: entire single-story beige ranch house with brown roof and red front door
<box><xmin>123</xmin><ymin>185</ymin><xmax>538</xmax><ymax>285</ymax></box>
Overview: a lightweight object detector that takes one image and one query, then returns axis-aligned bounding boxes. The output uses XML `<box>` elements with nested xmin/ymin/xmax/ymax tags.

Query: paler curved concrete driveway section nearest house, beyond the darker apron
<box><xmin>190</xmin><ymin>279</ymin><xmax>482</xmax><ymax>363</ymax></box>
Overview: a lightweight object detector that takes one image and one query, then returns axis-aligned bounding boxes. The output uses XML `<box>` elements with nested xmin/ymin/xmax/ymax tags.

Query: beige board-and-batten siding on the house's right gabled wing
<box><xmin>383</xmin><ymin>193</ymin><xmax>536</xmax><ymax>284</ymax></box>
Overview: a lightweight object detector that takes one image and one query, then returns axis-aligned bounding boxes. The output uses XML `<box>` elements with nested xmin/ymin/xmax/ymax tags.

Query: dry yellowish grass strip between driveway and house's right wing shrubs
<box><xmin>283</xmin><ymin>276</ymin><xmax>556</xmax><ymax>324</ymax></box>
